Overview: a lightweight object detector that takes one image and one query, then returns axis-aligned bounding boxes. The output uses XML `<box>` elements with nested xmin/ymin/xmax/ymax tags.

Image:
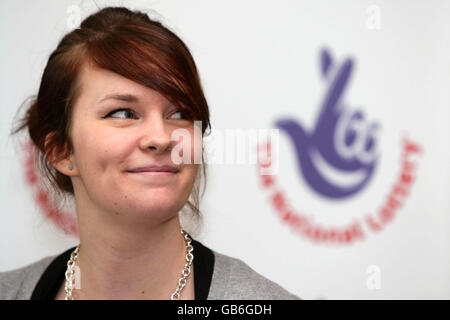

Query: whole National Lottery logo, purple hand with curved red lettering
<box><xmin>257</xmin><ymin>49</ymin><xmax>423</xmax><ymax>244</ymax></box>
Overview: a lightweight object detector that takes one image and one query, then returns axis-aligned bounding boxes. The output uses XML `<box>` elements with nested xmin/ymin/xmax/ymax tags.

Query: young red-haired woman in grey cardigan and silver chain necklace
<box><xmin>0</xmin><ymin>7</ymin><xmax>298</xmax><ymax>300</ymax></box>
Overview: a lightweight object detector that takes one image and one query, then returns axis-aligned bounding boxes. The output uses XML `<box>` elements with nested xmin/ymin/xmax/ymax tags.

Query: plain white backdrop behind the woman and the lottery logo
<box><xmin>0</xmin><ymin>0</ymin><xmax>450</xmax><ymax>299</ymax></box>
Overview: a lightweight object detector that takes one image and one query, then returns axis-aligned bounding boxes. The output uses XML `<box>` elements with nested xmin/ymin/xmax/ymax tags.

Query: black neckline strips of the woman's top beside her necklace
<box><xmin>30</xmin><ymin>237</ymin><xmax>214</xmax><ymax>300</ymax></box>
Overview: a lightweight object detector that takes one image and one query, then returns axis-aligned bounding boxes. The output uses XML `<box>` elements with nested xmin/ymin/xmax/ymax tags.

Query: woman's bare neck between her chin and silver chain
<box><xmin>66</xmin><ymin>211</ymin><xmax>193</xmax><ymax>299</ymax></box>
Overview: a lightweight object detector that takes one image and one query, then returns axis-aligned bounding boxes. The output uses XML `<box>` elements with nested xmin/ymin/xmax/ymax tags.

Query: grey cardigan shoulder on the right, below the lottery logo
<box><xmin>208</xmin><ymin>250</ymin><xmax>301</xmax><ymax>300</ymax></box>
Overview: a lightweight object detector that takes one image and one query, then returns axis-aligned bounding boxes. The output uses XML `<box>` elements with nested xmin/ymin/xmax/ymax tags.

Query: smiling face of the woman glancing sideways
<box><xmin>66</xmin><ymin>63</ymin><xmax>202</xmax><ymax>224</ymax></box>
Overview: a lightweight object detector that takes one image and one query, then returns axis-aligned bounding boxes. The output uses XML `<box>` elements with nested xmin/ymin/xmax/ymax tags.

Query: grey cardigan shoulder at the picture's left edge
<box><xmin>0</xmin><ymin>256</ymin><xmax>56</xmax><ymax>300</ymax></box>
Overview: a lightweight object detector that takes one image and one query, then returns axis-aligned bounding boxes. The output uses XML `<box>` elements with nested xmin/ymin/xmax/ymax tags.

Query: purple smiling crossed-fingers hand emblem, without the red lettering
<box><xmin>275</xmin><ymin>50</ymin><xmax>380</xmax><ymax>199</ymax></box>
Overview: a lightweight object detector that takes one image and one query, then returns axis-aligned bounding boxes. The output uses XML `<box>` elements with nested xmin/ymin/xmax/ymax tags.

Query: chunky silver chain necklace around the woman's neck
<box><xmin>64</xmin><ymin>229</ymin><xmax>194</xmax><ymax>300</ymax></box>
